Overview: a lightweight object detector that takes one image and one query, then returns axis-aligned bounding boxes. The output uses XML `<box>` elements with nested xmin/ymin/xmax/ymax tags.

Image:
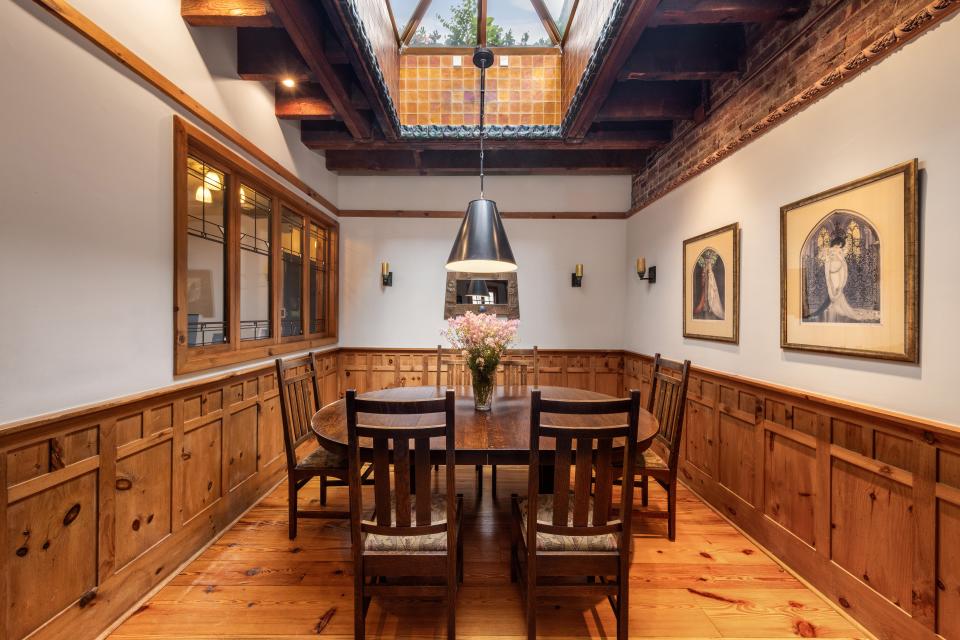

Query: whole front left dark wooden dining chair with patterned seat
<box><xmin>346</xmin><ymin>389</ymin><xmax>463</xmax><ymax>639</ymax></box>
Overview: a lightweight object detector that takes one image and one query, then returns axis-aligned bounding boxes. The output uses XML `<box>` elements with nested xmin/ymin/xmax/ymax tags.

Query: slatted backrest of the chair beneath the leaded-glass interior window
<box><xmin>276</xmin><ymin>355</ymin><xmax>320</xmax><ymax>470</ymax></box>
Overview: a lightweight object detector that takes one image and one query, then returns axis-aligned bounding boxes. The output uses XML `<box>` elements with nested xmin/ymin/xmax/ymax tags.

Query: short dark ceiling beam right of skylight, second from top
<box><xmin>618</xmin><ymin>24</ymin><xmax>745</xmax><ymax>81</ymax></box>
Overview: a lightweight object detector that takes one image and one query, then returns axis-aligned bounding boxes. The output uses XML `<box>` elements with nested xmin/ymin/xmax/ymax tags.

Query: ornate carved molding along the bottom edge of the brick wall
<box><xmin>626</xmin><ymin>0</ymin><xmax>960</xmax><ymax>218</ymax></box>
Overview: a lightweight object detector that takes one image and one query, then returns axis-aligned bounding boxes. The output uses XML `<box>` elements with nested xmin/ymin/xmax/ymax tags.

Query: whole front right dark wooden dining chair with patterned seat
<box><xmin>510</xmin><ymin>389</ymin><xmax>640</xmax><ymax>639</ymax></box>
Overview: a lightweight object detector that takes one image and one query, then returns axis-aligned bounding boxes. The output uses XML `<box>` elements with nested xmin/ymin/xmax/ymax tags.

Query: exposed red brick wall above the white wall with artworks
<box><xmin>631</xmin><ymin>0</ymin><xmax>960</xmax><ymax>211</ymax></box>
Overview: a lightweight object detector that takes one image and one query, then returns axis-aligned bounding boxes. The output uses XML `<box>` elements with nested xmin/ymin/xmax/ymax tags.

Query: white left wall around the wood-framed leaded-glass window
<box><xmin>0</xmin><ymin>0</ymin><xmax>337</xmax><ymax>424</ymax></box>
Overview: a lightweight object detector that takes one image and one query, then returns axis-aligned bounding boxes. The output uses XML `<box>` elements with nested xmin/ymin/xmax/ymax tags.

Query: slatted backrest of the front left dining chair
<box><xmin>346</xmin><ymin>389</ymin><xmax>455</xmax><ymax>544</ymax></box>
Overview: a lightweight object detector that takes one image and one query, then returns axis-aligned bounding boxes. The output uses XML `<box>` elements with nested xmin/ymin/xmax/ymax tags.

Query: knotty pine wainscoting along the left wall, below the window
<box><xmin>0</xmin><ymin>365</ymin><xmax>284</xmax><ymax>640</ymax></box>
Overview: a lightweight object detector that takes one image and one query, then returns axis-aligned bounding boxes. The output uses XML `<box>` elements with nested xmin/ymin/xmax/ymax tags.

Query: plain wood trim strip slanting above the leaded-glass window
<box><xmin>34</xmin><ymin>0</ymin><xmax>338</xmax><ymax>215</ymax></box>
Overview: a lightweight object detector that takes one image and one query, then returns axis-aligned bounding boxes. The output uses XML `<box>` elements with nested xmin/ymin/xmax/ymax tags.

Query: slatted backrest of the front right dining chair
<box><xmin>527</xmin><ymin>389</ymin><xmax>640</xmax><ymax>548</ymax></box>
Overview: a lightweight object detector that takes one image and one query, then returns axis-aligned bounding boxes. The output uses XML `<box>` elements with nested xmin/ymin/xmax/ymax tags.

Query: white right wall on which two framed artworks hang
<box><xmin>625</xmin><ymin>17</ymin><xmax>960</xmax><ymax>424</ymax></box>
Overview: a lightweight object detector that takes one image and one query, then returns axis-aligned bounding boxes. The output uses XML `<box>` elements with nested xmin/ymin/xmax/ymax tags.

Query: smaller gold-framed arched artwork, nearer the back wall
<box><xmin>683</xmin><ymin>223</ymin><xmax>740</xmax><ymax>344</ymax></box>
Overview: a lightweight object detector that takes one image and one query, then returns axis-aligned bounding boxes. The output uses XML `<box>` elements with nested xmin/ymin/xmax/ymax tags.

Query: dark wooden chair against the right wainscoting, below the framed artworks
<box><xmin>636</xmin><ymin>353</ymin><xmax>690</xmax><ymax>541</ymax></box>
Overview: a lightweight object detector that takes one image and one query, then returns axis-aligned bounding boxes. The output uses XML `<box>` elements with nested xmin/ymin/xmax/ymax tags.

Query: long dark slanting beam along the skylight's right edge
<box><xmin>567</xmin><ymin>0</ymin><xmax>659</xmax><ymax>139</ymax></box>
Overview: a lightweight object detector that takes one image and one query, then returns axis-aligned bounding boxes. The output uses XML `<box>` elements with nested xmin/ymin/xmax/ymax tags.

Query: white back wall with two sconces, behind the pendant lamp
<box><xmin>340</xmin><ymin>218</ymin><xmax>629</xmax><ymax>349</ymax></box>
